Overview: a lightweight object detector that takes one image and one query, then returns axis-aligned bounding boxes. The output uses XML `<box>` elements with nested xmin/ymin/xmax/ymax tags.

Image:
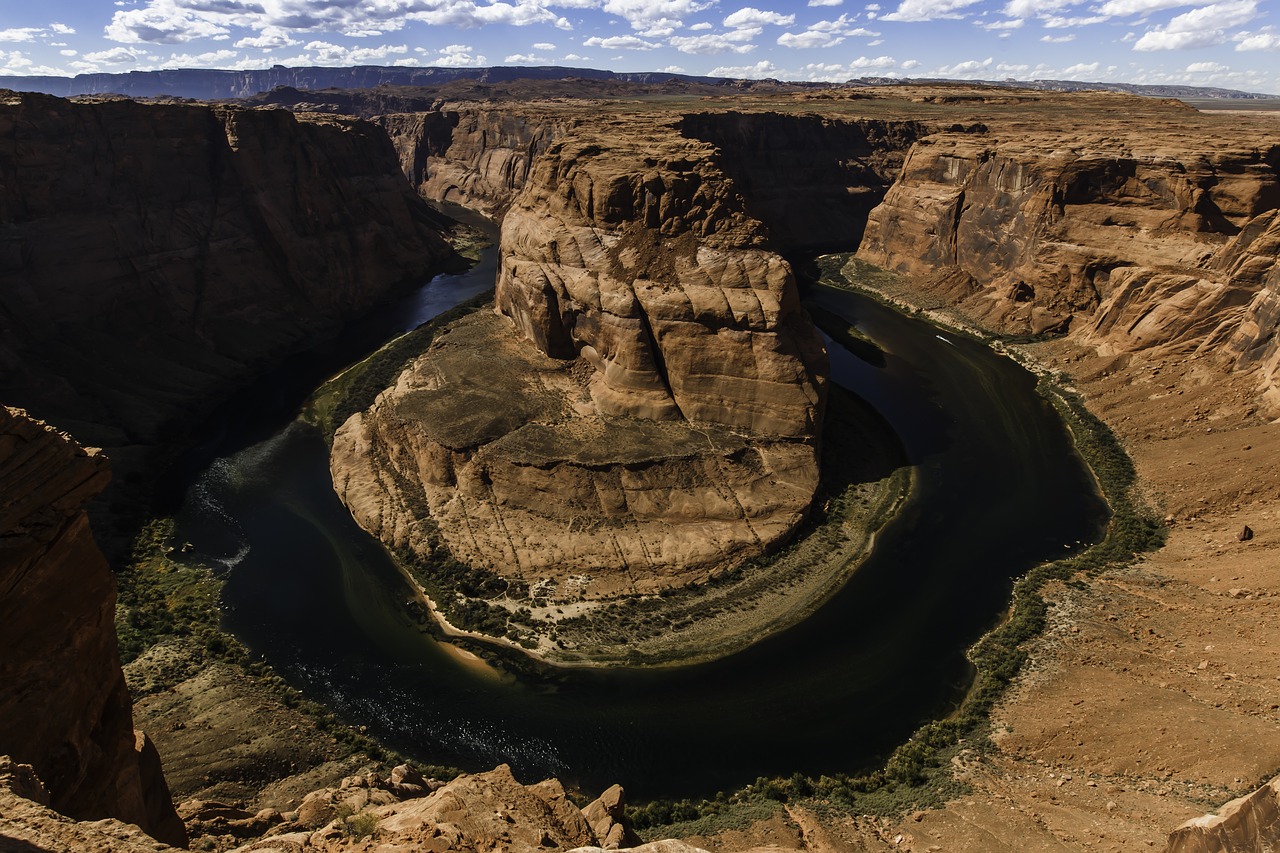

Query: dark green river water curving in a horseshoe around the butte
<box><xmin>170</xmin><ymin>251</ymin><xmax>1105</xmax><ymax>798</ymax></box>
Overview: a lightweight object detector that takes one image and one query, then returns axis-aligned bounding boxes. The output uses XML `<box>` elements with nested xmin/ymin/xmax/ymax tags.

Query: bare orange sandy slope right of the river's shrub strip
<box><xmin>670</xmin><ymin>253</ymin><xmax>1280</xmax><ymax>853</ymax></box>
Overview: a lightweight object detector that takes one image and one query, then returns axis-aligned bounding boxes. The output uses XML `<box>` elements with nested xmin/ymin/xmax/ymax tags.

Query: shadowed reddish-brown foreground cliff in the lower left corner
<box><xmin>0</xmin><ymin>409</ymin><xmax>186</xmax><ymax>844</ymax></box>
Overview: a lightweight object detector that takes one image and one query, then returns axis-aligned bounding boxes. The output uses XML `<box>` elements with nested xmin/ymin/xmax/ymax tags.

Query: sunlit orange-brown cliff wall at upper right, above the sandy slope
<box><xmin>859</xmin><ymin>122</ymin><xmax>1280</xmax><ymax>350</ymax></box>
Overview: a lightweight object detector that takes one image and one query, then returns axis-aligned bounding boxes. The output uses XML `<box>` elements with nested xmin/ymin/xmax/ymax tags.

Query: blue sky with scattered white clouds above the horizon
<box><xmin>0</xmin><ymin>0</ymin><xmax>1280</xmax><ymax>93</ymax></box>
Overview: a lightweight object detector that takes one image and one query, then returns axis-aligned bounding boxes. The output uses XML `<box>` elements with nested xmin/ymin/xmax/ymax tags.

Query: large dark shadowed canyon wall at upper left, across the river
<box><xmin>0</xmin><ymin>93</ymin><xmax>449</xmax><ymax>447</ymax></box>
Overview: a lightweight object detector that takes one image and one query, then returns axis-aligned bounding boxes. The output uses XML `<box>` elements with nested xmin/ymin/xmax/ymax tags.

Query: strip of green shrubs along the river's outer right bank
<box><xmin>630</xmin><ymin>255</ymin><xmax>1165</xmax><ymax>838</ymax></box>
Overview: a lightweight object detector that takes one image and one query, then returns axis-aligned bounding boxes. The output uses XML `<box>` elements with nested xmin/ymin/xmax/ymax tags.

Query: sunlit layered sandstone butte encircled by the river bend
<box><xmin>332</xmin><ymin>126</ymin><xmax>826</xmax><ymax>597</ymax></box>
